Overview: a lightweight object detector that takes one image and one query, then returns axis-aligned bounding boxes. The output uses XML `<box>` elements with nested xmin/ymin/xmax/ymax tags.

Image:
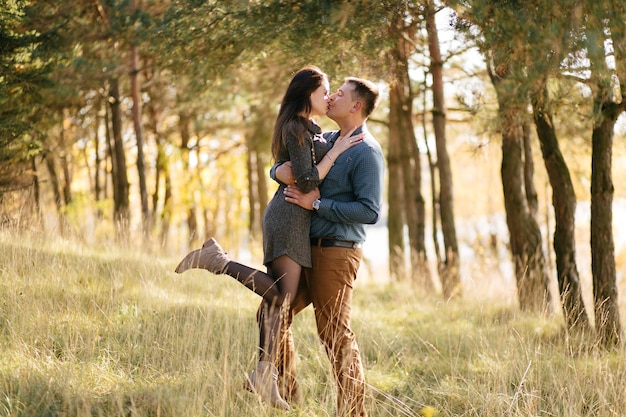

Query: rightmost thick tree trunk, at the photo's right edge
<box><xmin>583</xmin><ymin>2</ymin><xmax>626</xmax><ymax>346</ymax></box>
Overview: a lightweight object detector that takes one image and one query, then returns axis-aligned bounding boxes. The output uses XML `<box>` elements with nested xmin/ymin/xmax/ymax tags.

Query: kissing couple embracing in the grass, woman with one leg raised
<box><xmin>176</xmin><ymin>66</ymin><xmax>384</xmax><ymax>417</ymax></box>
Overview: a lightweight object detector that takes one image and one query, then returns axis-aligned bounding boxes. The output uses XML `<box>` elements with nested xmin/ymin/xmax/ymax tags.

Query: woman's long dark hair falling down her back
<box><xmin>272</xmin><ymin>65</ymin><xmax>328</xmax><ymax>160</ymax></box>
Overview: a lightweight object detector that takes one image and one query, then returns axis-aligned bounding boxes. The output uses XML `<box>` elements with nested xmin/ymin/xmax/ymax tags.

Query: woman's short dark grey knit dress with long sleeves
<box><xmin>263</xmin><ymin>119</ymin><xmax>328</xmax><ymax>268</ymax></box>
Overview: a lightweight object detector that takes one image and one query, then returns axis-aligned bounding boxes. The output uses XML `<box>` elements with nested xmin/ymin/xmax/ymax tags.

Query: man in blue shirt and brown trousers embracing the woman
<box><xmin>272</xmin><ymin>77</ymin><xmax>384</xmax><ymax>417</ymax></box>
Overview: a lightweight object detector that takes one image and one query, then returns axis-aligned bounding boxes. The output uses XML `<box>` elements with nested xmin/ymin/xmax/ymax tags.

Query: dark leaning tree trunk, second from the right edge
<box><xmin>532</xmin><ymin>88</ymin><xmax>589</xmax><ymax>331</ymax></box>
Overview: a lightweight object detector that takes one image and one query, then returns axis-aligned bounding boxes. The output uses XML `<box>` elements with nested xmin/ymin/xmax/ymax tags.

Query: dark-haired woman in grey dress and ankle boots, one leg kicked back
<box><xmin>176</xmin><ymin>66</ymin><xmax>363</xmax><ymax>410</ymax></box>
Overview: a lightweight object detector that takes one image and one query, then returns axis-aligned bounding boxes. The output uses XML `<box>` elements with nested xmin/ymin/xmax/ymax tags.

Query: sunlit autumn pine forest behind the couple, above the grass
<box><xmin>0</xmin><ymin>0</ymin><xmax>626</xmax><ymax>412</ymax></box>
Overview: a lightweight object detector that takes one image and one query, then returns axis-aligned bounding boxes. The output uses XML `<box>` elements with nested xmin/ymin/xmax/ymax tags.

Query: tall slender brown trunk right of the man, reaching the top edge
<box><xmin>425</xmin><ymin>0</ymin><xmax>463</xmax><ymax>300</ymax></box>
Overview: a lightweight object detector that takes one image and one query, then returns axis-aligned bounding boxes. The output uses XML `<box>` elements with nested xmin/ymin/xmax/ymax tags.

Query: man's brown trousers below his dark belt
<box><xmin>276</xmin><ymin>246</ymin><xmax>367</xmax><ymax>417</ymax></box>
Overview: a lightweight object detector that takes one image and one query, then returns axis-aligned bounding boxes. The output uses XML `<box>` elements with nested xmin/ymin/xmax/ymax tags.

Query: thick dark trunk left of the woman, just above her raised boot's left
<box><xmin>109</xmin><ymin>78</ymin><xmax>130</xmax><ymax>237</ymax></box>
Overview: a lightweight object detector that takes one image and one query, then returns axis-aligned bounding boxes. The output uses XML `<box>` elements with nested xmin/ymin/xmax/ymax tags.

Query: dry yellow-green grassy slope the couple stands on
<box><xmin>0</xmin><ymin>234</ymin><xmax>626</xmax><ymax>417</ymax></box>
